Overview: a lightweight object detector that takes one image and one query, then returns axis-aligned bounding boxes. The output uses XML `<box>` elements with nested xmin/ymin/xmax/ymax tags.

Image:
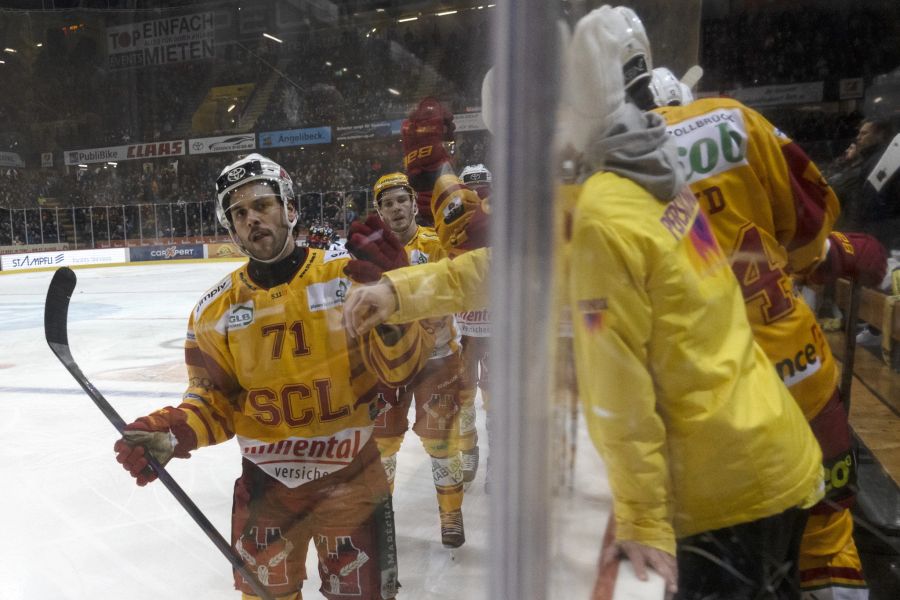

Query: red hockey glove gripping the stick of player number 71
<box><xmin>113</xmin><ymin>406</ymin><xmax>197</xmax><ymax>486</ymax></box>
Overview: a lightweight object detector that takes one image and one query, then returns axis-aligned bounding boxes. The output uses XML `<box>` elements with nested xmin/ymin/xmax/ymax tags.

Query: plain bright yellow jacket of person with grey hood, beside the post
<box><xmin>569</xmin><ymin>172</ymin><xmax>823</xmax><ymax>554</ymax></box>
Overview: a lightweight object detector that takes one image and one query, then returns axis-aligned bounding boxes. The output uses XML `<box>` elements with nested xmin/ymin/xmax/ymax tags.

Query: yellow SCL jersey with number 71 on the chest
<box><xmin>179</xmin><ymin>250</ymin><xmax>433</xmax><ymax>487</ymax></box>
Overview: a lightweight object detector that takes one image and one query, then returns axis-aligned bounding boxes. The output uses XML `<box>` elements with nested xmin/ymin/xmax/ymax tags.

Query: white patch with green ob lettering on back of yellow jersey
<box><xmin>666</xmin><ymin>109</ymin><xmax>748</xmax><ymax>184</ymax></box>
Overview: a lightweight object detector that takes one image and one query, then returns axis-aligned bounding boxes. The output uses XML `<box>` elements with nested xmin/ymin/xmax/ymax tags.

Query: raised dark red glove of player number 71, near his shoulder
<box><xmin>344</xmin><ymin>213</ymin><xmax>409</xmax><ymax>283</ymax></box>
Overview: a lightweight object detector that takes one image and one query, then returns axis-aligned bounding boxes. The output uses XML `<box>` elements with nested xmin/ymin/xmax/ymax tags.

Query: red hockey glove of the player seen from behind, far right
<box><xmin>810</xmin><ymin>231</ymin><xmax>887</xmax><ymax>286</ymax></box>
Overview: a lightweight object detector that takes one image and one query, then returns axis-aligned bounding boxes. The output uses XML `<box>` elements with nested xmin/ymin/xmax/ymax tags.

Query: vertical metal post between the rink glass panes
<box><xmin>487</xmin><ymin>0</ymin><xmax>560</xmax><ymax>600</ymax></box>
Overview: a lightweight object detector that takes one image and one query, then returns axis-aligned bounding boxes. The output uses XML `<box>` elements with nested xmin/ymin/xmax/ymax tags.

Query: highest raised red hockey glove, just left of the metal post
<box><xmin>400</xmin><ymin>97</ymin><xmax>456</xmax><ymax>176</ymax></box>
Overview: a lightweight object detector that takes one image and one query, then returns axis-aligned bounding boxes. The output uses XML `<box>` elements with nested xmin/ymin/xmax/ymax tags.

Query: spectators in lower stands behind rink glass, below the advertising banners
<box><xmin>0</xmin><ymin>132</ymin><xmax>487</xmax><ymax>246</ymax></box>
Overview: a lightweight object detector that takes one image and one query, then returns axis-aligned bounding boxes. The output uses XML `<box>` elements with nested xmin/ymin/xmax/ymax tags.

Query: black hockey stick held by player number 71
<box><xmin>44</xmin><ymin>267</ymin><xmax>272</xmax><ymax>600</ymax></box>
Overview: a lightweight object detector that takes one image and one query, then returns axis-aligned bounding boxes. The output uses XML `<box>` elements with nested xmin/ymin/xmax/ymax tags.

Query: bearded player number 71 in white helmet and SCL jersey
<box><xmin>115</xmin><ymin>154</ymin><xmax>433</xmax><ymax>600</ymax></box>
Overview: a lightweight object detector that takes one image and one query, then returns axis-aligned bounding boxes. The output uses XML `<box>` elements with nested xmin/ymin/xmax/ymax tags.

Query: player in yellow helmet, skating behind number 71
<box><xmin>350</xmin><ymin>173</ymin><xmax>475</xmax><ymax>548</ymax></box>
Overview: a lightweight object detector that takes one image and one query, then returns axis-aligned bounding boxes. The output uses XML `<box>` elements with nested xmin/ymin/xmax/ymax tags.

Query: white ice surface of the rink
<box><xmin>0</xmin><ymin>262</ymin><xmax>652</xmax><ymax>600</ymax></box>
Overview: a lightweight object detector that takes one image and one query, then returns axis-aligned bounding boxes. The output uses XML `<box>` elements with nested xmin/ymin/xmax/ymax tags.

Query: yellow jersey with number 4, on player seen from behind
<box><xmin>657</xmin><ymin>98</ymin><xmax>840</xmax><ymax>419</ymax></box>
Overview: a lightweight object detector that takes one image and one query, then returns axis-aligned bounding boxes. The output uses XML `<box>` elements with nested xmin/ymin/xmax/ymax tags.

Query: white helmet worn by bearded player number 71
<box><xmin>216</xmin><ymin>152</ymin><xmax>297</xmax><ymax>232</ymax></box>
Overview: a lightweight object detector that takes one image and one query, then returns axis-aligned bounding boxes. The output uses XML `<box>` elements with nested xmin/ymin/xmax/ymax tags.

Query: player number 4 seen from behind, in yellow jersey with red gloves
<box><xmin>604</xmin><ymin>7</ymin><xmax>887</xmax><ymax>600</ymax></box>
